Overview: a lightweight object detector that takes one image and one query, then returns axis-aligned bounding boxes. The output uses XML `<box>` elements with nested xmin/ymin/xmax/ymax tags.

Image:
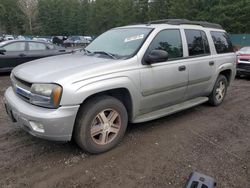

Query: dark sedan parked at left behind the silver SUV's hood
<box><xmin>0</xmin><ymin>40</ymin><xmax>71</xmax><ymax>72</ymax></box>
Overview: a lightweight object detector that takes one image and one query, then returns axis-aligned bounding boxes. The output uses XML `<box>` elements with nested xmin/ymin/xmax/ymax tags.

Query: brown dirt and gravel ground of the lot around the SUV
<box><xmin>0</xmin><ymin>75</ymin><xmax>250</xmax><ymax>188</ymax></box>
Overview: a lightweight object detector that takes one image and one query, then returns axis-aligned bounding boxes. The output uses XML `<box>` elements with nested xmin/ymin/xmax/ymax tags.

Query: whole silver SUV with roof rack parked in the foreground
<box><xmin>4</xmin><ymin>20</ymin><xmax>236</xmax><ymax>153</ymax></box>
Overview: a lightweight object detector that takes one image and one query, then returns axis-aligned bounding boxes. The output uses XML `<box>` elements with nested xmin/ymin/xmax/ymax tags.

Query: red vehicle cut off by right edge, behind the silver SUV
<box><xmin>237</xmin><ymin>47</ymin><xmax>250</xmax><ymax>76</ymax></box>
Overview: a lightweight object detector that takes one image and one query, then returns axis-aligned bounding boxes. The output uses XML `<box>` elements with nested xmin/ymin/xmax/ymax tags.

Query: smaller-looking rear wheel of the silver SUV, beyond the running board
<box><xmin>209</xmin><ymin>75</ymin><xmax>228</xmax><ymax>106</ymax></box>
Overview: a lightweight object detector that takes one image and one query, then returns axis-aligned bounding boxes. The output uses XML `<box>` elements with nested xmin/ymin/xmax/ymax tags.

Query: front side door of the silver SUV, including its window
<box><xmin>140</xmin><ymin>29</ymin><xmax>188</xmax><ymax>113</ymax></box>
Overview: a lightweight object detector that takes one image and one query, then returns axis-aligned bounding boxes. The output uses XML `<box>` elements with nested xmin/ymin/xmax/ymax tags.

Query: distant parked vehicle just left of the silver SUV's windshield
<box><xmin>63</xmin><ymin>36</ymin><xmax>90</xmax><ymax>47</ymax></box>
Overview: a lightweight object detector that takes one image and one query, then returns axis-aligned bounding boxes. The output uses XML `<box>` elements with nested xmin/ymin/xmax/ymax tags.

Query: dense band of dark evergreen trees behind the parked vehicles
<box><xmin>0</xmin><ymin>0</ymin><xmax>250</xmax><ymax>35</ymax></box>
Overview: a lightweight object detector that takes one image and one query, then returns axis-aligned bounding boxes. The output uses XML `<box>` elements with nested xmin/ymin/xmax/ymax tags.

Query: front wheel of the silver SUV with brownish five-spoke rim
<box><xmin>74</xmin><ymin>96</ymin><xmax>128</xmax><ymax>154</ymax></box>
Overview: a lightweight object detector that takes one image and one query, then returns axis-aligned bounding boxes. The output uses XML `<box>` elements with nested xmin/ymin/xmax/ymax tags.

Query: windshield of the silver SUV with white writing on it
<box><xmin>86</xmin><ymin>28</ymin><xmax>152</xmax><ymax>58</ymax></box>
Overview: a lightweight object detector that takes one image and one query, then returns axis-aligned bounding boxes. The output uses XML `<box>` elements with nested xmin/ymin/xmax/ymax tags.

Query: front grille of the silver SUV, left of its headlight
<box><xmin>11</xmin><ymin>75</ymin><xmax>32</xmax><ymax>102</ymax></box>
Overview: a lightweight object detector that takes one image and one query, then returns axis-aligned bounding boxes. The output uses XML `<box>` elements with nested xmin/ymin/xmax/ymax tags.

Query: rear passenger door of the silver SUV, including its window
<box><xmin>184</xmin><ymin>29</ymin><xmax>215</xmax><ymax>99</ymax></box>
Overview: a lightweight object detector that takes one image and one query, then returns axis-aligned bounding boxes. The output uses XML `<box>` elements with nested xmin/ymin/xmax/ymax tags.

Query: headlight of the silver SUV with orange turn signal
<box><xmin>30</xmin><ymin>84</ymin><xmax>62</xmax><ymax>108</ymax></box>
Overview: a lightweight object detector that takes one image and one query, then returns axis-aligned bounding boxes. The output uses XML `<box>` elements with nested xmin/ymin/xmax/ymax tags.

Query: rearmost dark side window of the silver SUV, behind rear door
<box><xmin>211</xmin><ymin>31</ymin><xmax>234</xmax><ymax>54</ymax></box>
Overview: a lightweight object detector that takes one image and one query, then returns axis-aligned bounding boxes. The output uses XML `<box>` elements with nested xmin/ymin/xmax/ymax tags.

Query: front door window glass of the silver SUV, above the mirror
<box><xmin>148</xmin><ymin>29</ymin><xmax>183</xmax><ymax>59</ymax></box>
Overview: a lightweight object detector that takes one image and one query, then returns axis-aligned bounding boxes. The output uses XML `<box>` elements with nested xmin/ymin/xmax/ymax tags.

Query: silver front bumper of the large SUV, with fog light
<box><xmin>4</xmin><ymin>87</ymin><xmax>79</xmax><ymax>141</ymax></box>
